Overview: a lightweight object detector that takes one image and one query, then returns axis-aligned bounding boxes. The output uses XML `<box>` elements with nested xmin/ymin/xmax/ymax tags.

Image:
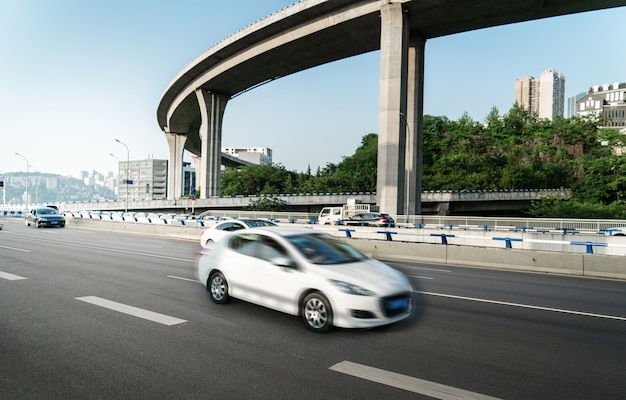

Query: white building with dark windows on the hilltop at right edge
<box><xmin>576</xmin><ymin>82</ymin><xmax>626</xmax><ymax>133</ymax></box>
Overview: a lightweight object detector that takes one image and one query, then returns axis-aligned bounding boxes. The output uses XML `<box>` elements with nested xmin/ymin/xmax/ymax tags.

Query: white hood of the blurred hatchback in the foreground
<box><xmin>312</xmin><ymin>259</ymin><xmax>412</xmax><ymax>293</ymax></box>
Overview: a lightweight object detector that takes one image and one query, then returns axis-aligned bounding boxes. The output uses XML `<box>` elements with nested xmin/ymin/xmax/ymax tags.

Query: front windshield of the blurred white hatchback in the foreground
<box><xmin>286</xmin><ymin>234</ymin><xmax>367</xmax><ymax>265</ymax></box>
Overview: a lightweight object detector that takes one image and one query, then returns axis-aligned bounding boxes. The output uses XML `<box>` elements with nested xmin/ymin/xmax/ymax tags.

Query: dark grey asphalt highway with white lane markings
<box><xmin>0</xmin><ymin>218</ymin><xmax>626</xmax><ymax>400</ymax></box>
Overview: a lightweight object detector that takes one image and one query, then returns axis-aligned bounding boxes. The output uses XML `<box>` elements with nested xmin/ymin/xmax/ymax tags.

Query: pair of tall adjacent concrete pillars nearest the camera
<box><xmin>376</xmin><ymin>3</ymin><xmax>425</xmax><ymax>215</ymax></box>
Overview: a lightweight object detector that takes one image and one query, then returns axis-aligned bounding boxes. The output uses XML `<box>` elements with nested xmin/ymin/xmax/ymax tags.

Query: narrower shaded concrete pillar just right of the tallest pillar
<box><xmin>404</xmin><ymin>32</ymin><xmax>426</xmax><ymax>215</ymax></box>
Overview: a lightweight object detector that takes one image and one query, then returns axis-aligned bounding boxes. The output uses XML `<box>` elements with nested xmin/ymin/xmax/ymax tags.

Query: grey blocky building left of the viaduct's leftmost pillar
<box><xmin>118</xmin><ymin>159</ymin><xmax>167</xmax><ymax>201</ymax></box>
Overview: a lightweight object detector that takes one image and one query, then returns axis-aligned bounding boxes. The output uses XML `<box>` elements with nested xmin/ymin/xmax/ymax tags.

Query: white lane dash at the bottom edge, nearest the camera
<box><xmin>329</xmin><ymin>361</ymin><xmax>497</xmax><ymax>400</ymax></box>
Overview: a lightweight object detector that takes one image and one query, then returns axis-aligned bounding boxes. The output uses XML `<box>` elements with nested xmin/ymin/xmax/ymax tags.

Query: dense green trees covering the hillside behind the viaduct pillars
<box><xmin>222</xmin><ymin>106</ymin><xmax>626</xmax><ymax>218</ymax></box>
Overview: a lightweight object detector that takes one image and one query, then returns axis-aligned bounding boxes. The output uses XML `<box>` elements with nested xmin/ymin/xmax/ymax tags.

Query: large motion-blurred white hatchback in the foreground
<box><xmin>198</xmin><ymin>227</ymin><xmax>413</xmax><ymax>332</ymax></box>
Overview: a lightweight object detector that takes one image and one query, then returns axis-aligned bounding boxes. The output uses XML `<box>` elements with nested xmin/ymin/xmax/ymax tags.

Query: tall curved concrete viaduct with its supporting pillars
<box><xmin>157</xmin><ymin>0</ymin><xmax>626</xmax><ymax>215</ymax></box>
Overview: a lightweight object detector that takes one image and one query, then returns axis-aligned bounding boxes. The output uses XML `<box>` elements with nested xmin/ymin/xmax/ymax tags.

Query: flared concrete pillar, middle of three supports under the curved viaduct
<box><xmin>196</xmin><ymin>89</ymin><xmax>229</xmax><ymax>199</ymax></box>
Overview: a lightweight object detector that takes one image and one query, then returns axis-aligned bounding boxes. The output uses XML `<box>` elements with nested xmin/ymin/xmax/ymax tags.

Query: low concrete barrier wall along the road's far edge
<box><xmin>66</xmin><ymin>218</ymin><xmax>626</xmax><ymax>279</ymax></box>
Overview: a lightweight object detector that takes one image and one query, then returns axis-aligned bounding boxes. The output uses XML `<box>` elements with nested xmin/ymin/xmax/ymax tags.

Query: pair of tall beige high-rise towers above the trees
<box><xmin>515</xmin><ymin>69</ymin><xmax>565</xmax><ymax>120</ymax></box>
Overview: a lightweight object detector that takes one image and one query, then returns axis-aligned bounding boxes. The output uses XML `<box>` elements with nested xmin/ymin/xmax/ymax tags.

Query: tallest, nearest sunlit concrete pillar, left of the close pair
<box><xmin>376</xmin><ymin>3</ymin><xmax>409</xmax><ymax>215</ymax></box>
